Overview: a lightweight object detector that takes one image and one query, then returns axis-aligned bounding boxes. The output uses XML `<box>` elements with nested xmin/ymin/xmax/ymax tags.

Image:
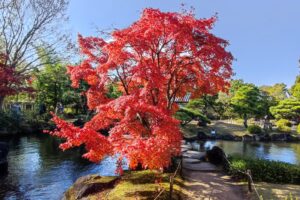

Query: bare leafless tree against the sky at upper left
<box><xmin>0</xmin><ymin>0</ymin><xmax>68</xmax><ymax>107</ymax></box>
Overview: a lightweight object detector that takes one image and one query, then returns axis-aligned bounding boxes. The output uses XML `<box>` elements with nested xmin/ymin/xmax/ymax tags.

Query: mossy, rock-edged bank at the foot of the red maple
<box><xmin>64</xmin><ymin>170</ymin><xmax>184</xmax><ymax>200</ymax></box>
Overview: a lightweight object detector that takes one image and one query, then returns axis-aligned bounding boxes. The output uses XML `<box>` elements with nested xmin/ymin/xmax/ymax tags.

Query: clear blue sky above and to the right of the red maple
<box><xmin>68</xmin><ymin>0</ymin><xmax>300</xmax><ymax>86</ymax></box>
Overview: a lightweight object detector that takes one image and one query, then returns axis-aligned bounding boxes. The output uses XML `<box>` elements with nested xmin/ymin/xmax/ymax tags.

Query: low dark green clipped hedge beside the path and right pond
<box><xmin>229</xmin><ymin>156</ymin><xmax>300</xmax><ymax>184</ymax></box>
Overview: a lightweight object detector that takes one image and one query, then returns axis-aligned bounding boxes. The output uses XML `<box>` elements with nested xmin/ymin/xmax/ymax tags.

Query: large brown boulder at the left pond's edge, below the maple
<box><xmin>63</xmin><ymin>174</ymin><xmax>119</xmax><ymax>200</ymax></box>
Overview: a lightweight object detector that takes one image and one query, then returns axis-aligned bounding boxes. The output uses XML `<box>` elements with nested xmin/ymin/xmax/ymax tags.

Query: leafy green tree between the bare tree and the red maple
<box><xmin>33</xmin><ymin>53</ymin><xmax>87</xmax><ymax>113</ymax></box>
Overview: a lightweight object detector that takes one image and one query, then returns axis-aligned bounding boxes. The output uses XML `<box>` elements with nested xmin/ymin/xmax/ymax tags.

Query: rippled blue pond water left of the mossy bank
<box><xmin>0</xmin><ymin>135</ymin><xmax>126</xmax><ymax>200</ymax></box>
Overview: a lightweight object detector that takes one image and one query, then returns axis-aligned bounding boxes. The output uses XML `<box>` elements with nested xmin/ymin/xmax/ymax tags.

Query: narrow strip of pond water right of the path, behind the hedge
<box><xmin>193</xmin><ymin>140</ymin><xmax>300</xmax><ymax>166</ymax></box>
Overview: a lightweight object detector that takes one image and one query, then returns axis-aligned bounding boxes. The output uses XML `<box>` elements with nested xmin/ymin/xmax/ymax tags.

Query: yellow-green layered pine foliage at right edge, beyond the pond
<box><xmin>270</xmin><ymin>98</ymin><xmax>300</xmax><ymax>120</ymax></box>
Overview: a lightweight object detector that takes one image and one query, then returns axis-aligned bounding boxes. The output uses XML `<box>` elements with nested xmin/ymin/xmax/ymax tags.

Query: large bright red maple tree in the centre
<box><xmin>47</xmin><ymin>9</ymin><xmax>233</xmax><ymax>169</ymax></box>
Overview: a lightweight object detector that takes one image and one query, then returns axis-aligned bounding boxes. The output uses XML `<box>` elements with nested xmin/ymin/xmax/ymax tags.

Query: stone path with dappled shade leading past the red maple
<box><xmin>182</xmin><ymin>141</ymin><xmax>249</xmax><ymax>200</ymax></box>
